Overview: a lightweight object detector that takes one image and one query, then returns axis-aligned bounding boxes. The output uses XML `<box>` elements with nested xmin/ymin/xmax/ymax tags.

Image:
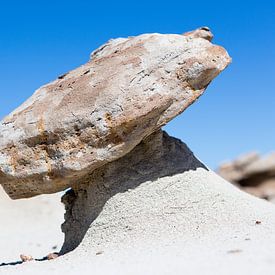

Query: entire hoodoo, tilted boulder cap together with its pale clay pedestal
<box><xmin>0</xmin><ymin>27</ymin><xmax>275</xmax><ymax>275</ymax></box>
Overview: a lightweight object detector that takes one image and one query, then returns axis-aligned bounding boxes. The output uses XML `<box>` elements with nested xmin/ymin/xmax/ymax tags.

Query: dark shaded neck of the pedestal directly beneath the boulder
<box><xmin>60</xmin><ymin>130</ymin><xmax>208</xmax><ymax>255</ymax></box>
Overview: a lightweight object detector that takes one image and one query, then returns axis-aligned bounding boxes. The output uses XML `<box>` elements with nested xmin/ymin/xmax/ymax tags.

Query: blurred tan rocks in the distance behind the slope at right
<box><xmin>218</xmin><ymin>153</ymin><xmax>275</xmax><ymax>202</ymax></box>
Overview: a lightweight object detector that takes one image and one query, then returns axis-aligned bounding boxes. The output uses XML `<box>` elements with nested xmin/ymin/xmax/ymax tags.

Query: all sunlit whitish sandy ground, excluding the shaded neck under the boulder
<box><xmin>0</xmin><ymin>168</ymin><xmax>275</xmax><ymax>275</ymax></box>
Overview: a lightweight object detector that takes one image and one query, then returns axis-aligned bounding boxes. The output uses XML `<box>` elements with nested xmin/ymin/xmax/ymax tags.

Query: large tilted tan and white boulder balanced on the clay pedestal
<box><xmin>0</xmin><ymin>28</ymin><xmax>230</xmax><ymax>199</ymax></box>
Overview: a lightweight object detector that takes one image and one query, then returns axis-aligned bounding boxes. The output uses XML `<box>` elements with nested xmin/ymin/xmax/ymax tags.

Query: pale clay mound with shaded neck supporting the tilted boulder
<box><xmin>0</xmin><ymin>133</ymin><xmax>275</xmax><ymax>275</ymax></box>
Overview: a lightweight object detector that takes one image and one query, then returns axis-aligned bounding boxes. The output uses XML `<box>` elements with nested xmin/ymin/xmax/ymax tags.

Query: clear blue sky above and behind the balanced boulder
<box><xmin>0</xmin><ymin>0</ymin><xmax>275</xmax><ymax>168</ymax></box>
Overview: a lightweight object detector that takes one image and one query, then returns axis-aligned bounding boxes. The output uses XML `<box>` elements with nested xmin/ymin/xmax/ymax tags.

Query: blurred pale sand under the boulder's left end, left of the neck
<box><xmin>0</xmin><ymin>188</ymin><xmax>64</xmax><ymax>266</ymax></box>
